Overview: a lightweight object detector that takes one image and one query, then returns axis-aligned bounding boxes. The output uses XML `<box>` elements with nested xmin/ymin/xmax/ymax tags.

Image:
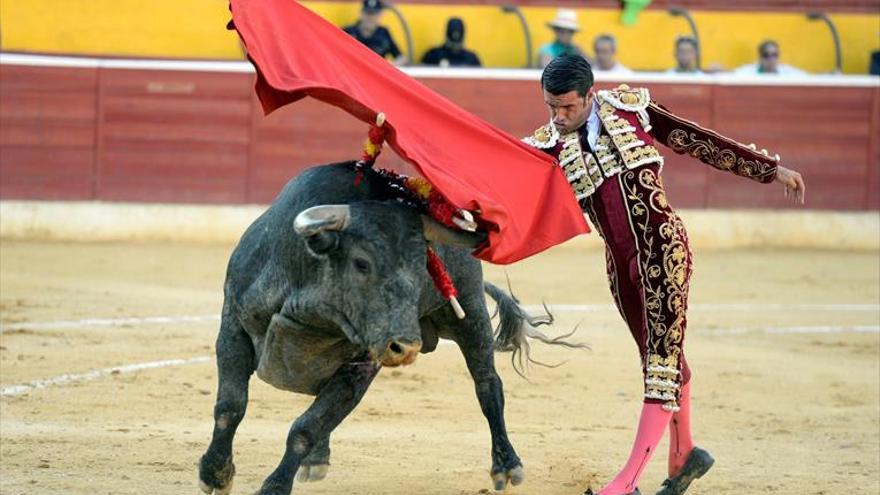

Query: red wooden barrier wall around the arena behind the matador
<box><xmin>0</xmin><ymin>64</ymin><xmax>880</xmax><ymax>210</ymax></box>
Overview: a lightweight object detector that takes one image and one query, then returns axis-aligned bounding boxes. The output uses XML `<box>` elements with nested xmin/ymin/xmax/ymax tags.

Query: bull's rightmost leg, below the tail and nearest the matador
<box><xmin>456</xmin><ymin>301</ymin><xmax>524</xmax><ymax>490</ymax></box>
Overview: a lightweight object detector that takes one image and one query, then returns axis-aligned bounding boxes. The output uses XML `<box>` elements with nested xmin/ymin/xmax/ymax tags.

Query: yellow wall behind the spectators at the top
<box><xmin>0</xmin><ymin>0</ymin><xmax>880</xmax><ymax>73</ymax></box>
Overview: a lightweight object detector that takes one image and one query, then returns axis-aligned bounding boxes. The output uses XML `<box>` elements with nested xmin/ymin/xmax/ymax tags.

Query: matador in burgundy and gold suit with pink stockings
<box><xmin>523</xmin><ymin>55</ymin><xmax>805</xmax><ymax>495</ymax></box>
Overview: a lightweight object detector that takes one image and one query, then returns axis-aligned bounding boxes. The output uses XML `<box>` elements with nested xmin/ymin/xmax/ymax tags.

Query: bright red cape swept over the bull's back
<box><xmin>230</xmin><ymin>0</ymin><xmax>589</xmax><ymax>264</ymax></box>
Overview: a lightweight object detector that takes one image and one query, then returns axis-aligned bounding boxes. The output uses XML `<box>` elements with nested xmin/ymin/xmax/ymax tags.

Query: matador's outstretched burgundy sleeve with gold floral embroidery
<box><xmin>646</xmin><ymin>101</ymin><xmax>779</xmax><ymax>184</ymax></box>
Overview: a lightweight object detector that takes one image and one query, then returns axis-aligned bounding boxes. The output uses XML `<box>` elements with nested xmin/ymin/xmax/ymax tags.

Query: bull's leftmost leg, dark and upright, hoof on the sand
<box><xmin>199</xmin><ymin>315</ymin><xmax>254</xmax><ymax>495</ymax></box>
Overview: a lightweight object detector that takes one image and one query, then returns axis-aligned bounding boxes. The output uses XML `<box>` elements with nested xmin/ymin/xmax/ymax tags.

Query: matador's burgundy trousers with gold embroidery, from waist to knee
<box><xmin>581</xmin><ymin>165</ymin><xmax>692</xmax><ymax>411</ymax></box>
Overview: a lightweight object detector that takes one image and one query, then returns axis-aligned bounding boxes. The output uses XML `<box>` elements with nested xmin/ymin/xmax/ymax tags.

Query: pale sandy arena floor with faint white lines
<box><xmin>0</xmin><ymin>241</ymin><xmax>880</xmax><ymax>495</ymax></box>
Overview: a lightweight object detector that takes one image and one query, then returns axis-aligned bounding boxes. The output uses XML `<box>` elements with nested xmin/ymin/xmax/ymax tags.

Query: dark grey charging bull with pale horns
<box><xmin>199</xmin><ymin>163</ymin><xmax>565</xmax><ymax>495</ymax></box>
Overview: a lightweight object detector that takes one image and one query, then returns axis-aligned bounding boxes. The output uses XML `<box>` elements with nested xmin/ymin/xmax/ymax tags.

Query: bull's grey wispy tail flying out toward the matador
<box><xmin>483</xmin><ymin>282</ymin><xmax>589</xmax><ymax>378</ymax></box>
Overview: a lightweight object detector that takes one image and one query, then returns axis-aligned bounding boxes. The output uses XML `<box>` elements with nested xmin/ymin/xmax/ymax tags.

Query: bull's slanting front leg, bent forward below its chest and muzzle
<box><xmin>257</xmin><ymin>362</ymin><xmax>379</xmax><ymax>495</ymax></box>
